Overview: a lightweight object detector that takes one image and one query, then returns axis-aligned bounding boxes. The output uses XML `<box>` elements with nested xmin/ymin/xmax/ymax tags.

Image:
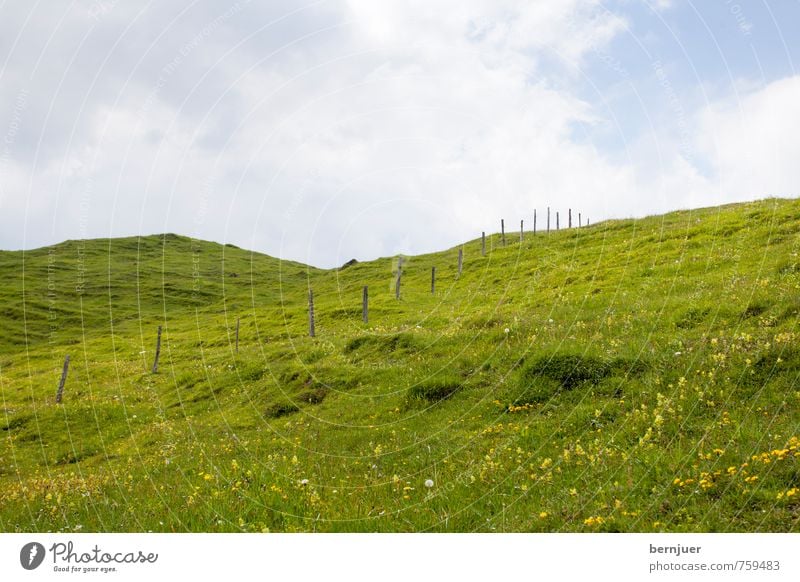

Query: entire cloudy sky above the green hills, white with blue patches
<box><xmin>0</xmin><ymin>0</ymin><xmax>800</xmax><ymax>267</ymax></box>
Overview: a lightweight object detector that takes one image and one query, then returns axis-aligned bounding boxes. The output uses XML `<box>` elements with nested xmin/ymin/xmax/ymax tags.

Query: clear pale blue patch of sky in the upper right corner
<box><xmin>581</xmin><ymin>0</ymin><xmax>800</xmax><ymax>152</ymax></box>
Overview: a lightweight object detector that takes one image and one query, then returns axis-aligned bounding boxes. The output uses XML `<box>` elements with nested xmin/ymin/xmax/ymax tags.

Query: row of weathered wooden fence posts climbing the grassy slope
<box><xmin>51</xmin><ymin>206</ymin><xmax>589</xmax><ymax>404</ymax></box>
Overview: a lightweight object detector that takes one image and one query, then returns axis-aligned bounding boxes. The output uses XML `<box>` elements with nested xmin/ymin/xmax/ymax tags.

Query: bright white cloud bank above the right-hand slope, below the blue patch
<box><xmin>614</xmin><ymin>76</ymin><xmax>800</xmax><ymax>216</ymax></box>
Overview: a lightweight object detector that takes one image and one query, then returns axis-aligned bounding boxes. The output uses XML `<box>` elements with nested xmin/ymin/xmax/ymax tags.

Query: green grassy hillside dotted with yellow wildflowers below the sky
<box><xmin>0</xmin><ymin>200</ymin><xmax>800</xmax><ymax>532</ymax></box>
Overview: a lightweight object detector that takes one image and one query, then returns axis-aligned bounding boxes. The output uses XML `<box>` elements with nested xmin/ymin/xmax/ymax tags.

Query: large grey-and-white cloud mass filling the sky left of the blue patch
<box><xmin>3</xmin><ymin>0</ymin><xmax>627</xmax><ymax>265</ymax></box>
